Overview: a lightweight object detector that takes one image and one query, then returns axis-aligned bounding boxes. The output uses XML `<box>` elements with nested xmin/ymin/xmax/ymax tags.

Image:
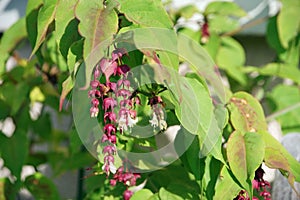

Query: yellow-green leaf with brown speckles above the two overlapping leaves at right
<box><xmin>228</xmin><ymin>92</ymin><xmax>267</xmax><ymax>132</ymax></box>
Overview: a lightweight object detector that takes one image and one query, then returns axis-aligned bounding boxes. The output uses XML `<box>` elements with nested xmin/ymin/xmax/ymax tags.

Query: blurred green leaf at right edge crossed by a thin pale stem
<box><xmin>268</xmin><ymin>85</ymin><xmax>300</xmax><ymax>133</ymax></box>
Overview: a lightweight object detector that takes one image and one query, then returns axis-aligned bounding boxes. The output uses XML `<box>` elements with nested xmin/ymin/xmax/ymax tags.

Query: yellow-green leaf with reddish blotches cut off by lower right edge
<box><xmin>259</xmin><ymin>131</ymin><xmax>300</xmax><ymax>183</ymax></box>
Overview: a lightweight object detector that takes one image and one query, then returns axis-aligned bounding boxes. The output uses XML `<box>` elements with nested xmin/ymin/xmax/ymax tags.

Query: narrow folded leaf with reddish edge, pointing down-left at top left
<box><xmin>30</xmin><ymin>0</ymin><xmax>59</xmax><ymax>57</ymax></box>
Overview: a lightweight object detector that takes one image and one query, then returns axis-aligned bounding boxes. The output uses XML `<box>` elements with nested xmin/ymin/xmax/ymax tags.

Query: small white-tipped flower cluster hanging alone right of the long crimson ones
<box><xmin>148</xmin><ymin>96</ymin><xmax>167</xmax><ymax>131</ymax></box>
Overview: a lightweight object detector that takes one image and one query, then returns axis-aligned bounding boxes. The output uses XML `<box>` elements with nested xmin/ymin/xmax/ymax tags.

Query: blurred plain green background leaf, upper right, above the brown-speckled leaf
<box><xmin>216</xmin><ymin>37</ymin><xmax>247</xmax><ymax>85</ymax></box>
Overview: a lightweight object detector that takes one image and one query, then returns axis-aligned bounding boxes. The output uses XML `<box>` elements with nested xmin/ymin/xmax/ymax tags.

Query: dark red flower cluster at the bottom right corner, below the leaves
<box><xmin>234</xmin><ymin>166</ymin><xmax>271</xmax><ymax>200</ymax></box>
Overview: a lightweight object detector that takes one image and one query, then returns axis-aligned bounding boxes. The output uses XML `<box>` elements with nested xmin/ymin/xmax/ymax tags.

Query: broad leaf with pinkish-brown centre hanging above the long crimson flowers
<box><xmin>75</xmin><ymin>0</ymin><xmax>118</xmax><ymax>87</ymax></box>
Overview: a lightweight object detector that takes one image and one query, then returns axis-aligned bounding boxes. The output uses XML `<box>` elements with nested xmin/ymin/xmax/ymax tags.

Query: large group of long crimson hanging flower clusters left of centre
<box><xmin>89</xmin><ymin>49</ymin><xmax>140</xmax><ymax>199</ymax></box>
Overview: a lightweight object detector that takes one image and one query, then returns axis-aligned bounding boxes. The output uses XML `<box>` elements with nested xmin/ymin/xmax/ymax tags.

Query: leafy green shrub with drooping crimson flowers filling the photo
<box><xmin>0</xmin><ymin>0</ymin><xmax>300</xmax><ymax>200</ymax></box>
